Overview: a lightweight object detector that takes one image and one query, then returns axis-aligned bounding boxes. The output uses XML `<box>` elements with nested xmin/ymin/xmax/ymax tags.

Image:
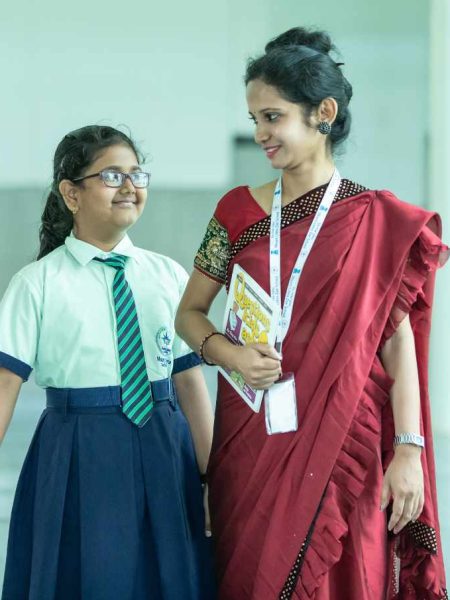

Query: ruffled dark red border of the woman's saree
<box><xmin>279</xmin><ymin>225</ymin><xmax>449</xmax><ymax>600</ymax></box>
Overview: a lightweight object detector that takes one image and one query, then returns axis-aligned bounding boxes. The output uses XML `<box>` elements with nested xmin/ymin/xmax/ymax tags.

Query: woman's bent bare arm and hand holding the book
<box><xmin>175</xmin><ymin>270</ymin><xmax>281</xmax><ymax>389</ymax></box>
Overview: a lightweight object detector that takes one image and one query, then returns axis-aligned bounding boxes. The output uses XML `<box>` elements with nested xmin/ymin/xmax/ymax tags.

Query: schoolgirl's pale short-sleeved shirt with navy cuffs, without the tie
<box><xmin>0</xmin><ymin>235</ymin><xmax>200</xmax><ymax>388</ymax></box>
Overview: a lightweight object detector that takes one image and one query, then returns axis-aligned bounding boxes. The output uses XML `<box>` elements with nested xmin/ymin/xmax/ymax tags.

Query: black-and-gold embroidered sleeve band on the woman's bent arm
<box><xmin>194</xmin><ymin>214</ymin><xmax>231</xmax><ymax>284</ymax></box>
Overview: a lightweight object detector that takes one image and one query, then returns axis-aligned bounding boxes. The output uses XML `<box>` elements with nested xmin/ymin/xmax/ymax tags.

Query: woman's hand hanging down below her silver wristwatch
<box><xmin>381</xmin><ymin>444</ymin><xmax>424</xmax><ymax>533</ymax></box>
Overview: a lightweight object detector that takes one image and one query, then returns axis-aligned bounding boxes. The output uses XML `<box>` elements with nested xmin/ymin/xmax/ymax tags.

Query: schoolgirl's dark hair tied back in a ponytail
<box><xmin>38</xmin><ymin>125</ymin><xmax>142</xmax><ymax>260</ymax></box>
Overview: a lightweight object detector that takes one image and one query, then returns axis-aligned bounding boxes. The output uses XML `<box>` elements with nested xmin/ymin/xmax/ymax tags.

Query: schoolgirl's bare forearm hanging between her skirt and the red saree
<box><xmin>173</xmin><ymin>367</ymin><xmax>213</xmax><ymax>474</ymax></box>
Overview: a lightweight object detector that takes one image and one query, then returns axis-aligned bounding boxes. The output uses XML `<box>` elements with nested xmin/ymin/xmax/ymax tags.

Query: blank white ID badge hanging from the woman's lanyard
<box><xmin>264</xmin><ymin>373</ymin><xmax>298</xmax><ymax>435</ymax></box>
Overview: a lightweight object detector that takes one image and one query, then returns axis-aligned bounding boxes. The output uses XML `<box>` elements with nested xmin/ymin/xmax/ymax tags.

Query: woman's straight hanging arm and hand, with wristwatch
<box><xmin>381</xmin><ymin>316</ymin><xmax>426</xmax><ymax>533</ymax></box>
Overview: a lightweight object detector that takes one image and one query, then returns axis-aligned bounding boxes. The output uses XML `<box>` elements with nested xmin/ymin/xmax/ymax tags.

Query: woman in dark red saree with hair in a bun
<box><xmin>177</xmin><ymin>28</ymin><xmax>447</xmax><ymax>600</ymax></box>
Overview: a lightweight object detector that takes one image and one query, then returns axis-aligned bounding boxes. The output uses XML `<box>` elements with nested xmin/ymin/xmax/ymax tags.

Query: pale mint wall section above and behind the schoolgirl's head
<box><xmin>0</xmin><ymin>0</ymin><xmax>229</xmax><ymax>187</ymax></box>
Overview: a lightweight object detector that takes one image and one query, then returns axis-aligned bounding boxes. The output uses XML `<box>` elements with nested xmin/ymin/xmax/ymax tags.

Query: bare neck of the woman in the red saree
<box><xmin>282</xmin><ymin>157</ymin><xmax>335</xmax><ymax>205</ymax></box>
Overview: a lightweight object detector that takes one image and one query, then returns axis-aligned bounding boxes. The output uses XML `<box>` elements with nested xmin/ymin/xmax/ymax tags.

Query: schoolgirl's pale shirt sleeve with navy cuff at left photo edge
<box><xmin>0</xmin><ymin>273</ymin><xmax>42</xmax><ymax>381</ymax></box>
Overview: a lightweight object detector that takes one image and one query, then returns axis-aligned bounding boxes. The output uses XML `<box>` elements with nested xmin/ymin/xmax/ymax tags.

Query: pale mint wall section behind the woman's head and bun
<box><xmin>231</xmin><ymin>0</ymin><xmax>429</xmax><ymax>204</ymax></box>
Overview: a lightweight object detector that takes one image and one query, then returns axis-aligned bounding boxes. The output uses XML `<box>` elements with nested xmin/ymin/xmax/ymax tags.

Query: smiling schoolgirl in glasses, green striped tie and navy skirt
<box><xmin>0</xmin><ymin>126</ymin><xmax>214</xmax><ymax>600</ymax></box>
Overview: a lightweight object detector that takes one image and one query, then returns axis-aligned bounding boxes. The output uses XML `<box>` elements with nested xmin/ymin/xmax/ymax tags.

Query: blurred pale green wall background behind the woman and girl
<box><xmin>0</xmin><ymin>0</ymin><xmax>450</xmax><ymax>581</ymax></box>
